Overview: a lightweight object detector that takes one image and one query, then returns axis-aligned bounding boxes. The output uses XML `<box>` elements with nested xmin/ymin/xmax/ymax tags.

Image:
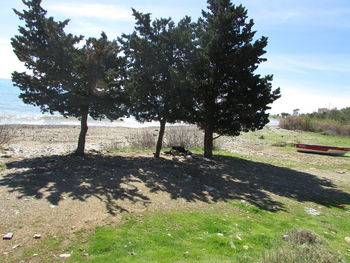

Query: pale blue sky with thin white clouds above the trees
<box><xmin>0</xmin><ymin>0</ymin><xmax>350</xmax><ymax>114</ymax></box>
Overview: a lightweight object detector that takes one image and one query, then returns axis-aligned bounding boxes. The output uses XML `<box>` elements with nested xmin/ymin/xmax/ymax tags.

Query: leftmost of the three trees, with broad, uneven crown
<box><xmin>12</xmin><ymin>0</ymin><xmax>125</xmax><ymax>155</ymax></box>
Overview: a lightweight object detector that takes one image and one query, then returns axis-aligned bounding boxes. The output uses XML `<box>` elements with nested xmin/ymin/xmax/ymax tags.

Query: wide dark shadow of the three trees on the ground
<box><xmin>0</xmin><ymin>154</ymin><xmax>350</xmax><ymax>214</ymax></box>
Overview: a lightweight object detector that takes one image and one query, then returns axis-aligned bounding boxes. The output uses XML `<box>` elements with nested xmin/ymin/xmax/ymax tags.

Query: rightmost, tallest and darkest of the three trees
<box><xmin>189</xmin><ymin>0</ymin><xmax>280</xmax><ymax>158</ymax></box>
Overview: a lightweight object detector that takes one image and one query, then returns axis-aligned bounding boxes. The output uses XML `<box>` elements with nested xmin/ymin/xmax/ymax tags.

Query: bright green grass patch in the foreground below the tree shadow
<box><xmin>60</xmin><ymin>201</ymin><xmax>350</xmax><ymax>263</ymax></box>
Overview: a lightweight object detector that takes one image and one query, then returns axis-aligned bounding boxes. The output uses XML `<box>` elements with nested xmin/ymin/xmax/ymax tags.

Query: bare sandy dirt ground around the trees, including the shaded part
<box><xmin>0</xmin><ymin>126</ymin><xmax>350</xmax><ymax>262</ymax></box>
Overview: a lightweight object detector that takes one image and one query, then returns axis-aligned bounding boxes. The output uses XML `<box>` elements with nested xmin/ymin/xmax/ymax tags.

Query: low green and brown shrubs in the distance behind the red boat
<box><xmin>279</xmin><ymin>108</ymin><xmax>350</xmax><ymax>137</ymax></box>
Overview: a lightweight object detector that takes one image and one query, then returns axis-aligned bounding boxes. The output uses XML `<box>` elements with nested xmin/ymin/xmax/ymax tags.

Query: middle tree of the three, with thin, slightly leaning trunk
<box><xmin>119</xmin><ymin>9</ymin><xmax>193</xmax><ymax>157</ymax></box>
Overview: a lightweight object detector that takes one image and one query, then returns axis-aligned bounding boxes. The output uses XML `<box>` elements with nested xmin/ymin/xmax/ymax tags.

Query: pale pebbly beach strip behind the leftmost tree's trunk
<box><xmin>0</xmin><ymin>125</ymin><xmax>144</xmax><ymax>157</ymax></box>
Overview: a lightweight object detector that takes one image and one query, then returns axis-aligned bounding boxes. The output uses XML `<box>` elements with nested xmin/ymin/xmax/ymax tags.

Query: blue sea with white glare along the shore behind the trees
<box><xmin>0</xmin><ymin>79</ymin><xmax>278</xmax><ymax>128</ymax></box>
